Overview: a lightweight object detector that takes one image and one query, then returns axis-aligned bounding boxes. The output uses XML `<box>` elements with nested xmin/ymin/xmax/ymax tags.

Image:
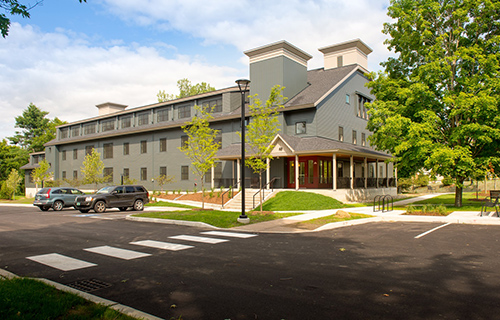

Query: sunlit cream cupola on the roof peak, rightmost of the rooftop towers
<box><xmin>318</xmin><ymin>39</ymin><xmax>373</xmax><ymax>71</ymax></box>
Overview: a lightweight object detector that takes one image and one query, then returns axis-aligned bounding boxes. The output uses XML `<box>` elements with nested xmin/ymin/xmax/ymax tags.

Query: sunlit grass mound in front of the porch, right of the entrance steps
<box><xmin>262</xmin><ymin>191</ymin><xmax>356</xmax><ymax>211</ymax></box>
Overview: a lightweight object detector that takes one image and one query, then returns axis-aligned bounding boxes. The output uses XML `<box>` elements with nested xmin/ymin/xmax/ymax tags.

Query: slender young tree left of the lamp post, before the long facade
<box><xmin>179</xmin><ymin>106</ymin><xmax>220</xmax><ymax>209</ymax></box>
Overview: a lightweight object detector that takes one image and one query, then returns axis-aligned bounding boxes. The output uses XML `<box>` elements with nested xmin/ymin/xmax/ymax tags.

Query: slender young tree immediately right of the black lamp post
<box><xmin>240</xmin><ymin>85</ymin><xmax>285</xmax><ymax>211</ymax></box>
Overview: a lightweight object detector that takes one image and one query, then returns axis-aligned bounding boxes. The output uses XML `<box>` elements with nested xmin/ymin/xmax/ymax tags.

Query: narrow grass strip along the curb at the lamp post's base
<box><xmin>134</xmin><ymin>210</ymin><xmax>300</xmax><ymax>228</ymax></box>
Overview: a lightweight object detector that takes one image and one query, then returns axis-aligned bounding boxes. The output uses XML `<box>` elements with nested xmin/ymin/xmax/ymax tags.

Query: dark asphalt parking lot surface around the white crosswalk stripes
<box><xmin>0</xmin><ymin>207</ymin><xmax>500</xmax><ymax>319</ymax></box>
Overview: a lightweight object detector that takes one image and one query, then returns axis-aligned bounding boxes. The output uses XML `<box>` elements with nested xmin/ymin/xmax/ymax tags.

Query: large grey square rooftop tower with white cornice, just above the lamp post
<box><xmin>244</xmin><ymin>40</ymin><xmax>312</xmax><ymax>102</ymax></box>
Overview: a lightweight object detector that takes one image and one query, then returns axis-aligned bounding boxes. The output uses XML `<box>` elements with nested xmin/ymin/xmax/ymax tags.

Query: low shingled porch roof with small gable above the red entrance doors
<box><xmin>217</xmin><ymin>134</ymin><xmax>391</xmax><ymax>160</ymax></box>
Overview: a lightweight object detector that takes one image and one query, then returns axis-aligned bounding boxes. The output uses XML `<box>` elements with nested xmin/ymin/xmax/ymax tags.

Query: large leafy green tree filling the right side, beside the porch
<box><xmin>368</xmin><ymin>0</ymin><xmax>500</xmax><ymax>206</ymax></box>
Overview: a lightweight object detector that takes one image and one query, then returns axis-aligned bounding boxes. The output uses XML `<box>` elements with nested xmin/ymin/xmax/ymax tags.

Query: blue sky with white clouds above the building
<box><xmin>0</xmin><ymin>0</ymin><xmax>393</xmax><ymax>139</ymax></box>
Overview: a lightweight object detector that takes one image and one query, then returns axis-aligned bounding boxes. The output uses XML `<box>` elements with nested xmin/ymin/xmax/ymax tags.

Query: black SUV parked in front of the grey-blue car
<box><xmin>75</xmin><ymin>186</ymin><xmax>149</xmax><ymax>213</ymax></box>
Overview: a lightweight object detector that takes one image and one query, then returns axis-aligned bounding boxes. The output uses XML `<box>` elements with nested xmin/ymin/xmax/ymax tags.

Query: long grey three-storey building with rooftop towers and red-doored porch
<box><xmin>24</xmin><ymin>39</ymin><xmax>396</xmax><ymax>201</ymax></box>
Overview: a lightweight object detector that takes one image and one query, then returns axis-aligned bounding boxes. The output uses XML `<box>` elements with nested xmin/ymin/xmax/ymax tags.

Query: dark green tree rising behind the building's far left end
<box><xmin>8</xmin><ymin>103</ymin><xmax>66</xmax><ymax>152</ymax></box>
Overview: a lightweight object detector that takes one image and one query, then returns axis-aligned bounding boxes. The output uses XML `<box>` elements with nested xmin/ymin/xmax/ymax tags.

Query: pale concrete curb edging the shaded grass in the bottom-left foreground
<box><xmin>0</xmin><ymin>269</ymin><xmax>164</xmax><ymax>320</ymax></box>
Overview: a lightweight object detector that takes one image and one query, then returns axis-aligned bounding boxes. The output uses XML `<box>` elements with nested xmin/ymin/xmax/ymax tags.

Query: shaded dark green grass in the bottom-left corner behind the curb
<box><xmin>0</xmin><ymin>277</ymin><xmax>136</xmax><ymax>320</ymax></box>
